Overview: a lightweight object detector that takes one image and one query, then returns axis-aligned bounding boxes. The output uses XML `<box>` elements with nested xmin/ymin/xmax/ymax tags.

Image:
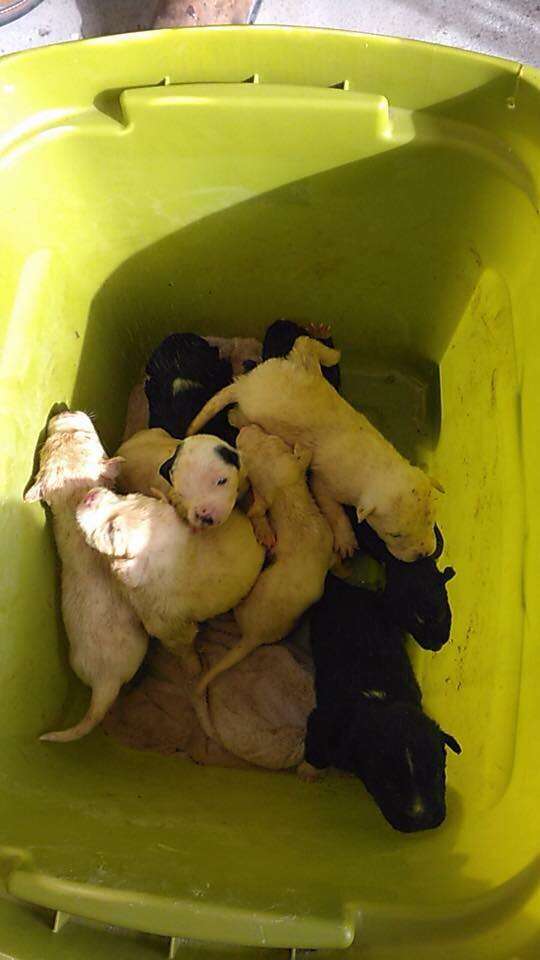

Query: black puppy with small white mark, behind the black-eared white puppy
<box><xmin>144</xmin><ymin>333</ymin><xmax>238</xmax><ymax>446</ymax></box>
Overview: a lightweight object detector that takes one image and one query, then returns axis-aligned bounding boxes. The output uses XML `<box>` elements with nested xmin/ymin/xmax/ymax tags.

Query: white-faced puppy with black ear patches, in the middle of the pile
<box><xmin>117</xmin><ymin>429</ymin><xmax>247</xmax><ymax>530</ymax></box>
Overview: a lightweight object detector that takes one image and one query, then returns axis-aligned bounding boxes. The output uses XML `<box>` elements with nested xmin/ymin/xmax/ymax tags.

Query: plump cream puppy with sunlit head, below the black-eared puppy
<box><xmin>77</xmin><ymin>487</ymin><xmax>264</xmax><ymax>672</ymax></box>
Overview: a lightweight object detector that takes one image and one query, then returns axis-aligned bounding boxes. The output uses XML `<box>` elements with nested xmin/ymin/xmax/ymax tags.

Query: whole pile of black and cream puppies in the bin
<box><xmin>25</xmin><ymin>321</ymin><xmax>460</xmax><ymax>831</ymax></box>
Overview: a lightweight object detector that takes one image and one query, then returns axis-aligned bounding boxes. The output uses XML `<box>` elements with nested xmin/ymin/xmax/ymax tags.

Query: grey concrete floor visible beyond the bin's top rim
<box><xmin>0</xmin><ymin>0</ymin><xmax>540</xmax><ymax>66</ymax></box>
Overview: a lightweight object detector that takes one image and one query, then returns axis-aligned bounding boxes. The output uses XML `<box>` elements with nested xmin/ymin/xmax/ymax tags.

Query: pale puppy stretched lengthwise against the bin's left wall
<box><xmin>24</xmin><ymin>413</ymin><xmax>148</xmax><ymax>741</ymax></box>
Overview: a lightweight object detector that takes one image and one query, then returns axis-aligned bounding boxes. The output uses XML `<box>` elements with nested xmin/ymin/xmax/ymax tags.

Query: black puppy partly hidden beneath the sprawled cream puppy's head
<box><xmin>345</xmin><ymin>507</ymin><xmax>456</xmax><ymax>650</ymax></box>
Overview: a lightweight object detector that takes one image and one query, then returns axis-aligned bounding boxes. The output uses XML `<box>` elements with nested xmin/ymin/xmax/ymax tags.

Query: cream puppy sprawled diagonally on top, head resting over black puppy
<box><xmin>188</xmin><ymin>337</ymin><xmax>440</xmax><ymax>561</ymax></box>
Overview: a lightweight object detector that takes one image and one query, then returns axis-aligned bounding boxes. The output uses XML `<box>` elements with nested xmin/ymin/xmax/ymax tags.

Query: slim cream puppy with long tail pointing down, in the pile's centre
<box><xmin>197</xmin><ymin>426</ymin><xmax>335</xmax><ymax>693</ymax></box>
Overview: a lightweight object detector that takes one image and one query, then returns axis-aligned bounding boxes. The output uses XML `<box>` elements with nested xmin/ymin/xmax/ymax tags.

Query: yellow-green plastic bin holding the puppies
<box><xmin>0</xmin><ymin>28</ymin><xmax>540</xmax><ymax>960</ymax></box>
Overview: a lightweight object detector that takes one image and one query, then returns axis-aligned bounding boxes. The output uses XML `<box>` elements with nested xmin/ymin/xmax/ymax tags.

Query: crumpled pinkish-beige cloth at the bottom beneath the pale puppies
<box><xmin>103</xmin><ymin>616</ymin><xmax>315</xmax><ymax>770</ymax></box>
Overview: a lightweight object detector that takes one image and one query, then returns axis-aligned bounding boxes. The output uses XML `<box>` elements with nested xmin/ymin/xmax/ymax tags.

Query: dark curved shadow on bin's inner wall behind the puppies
<box><xmin>73</xmin><ymin>77</ymin><xmax>536</xmax><ymax>455</ymax></box>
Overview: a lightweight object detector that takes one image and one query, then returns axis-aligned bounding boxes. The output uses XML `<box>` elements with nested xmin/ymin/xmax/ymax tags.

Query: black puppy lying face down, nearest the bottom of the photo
<box><xmin>305</xmin><ymin>575</ymin><xmax>461</xmax><ymax>832</ymax></box>
